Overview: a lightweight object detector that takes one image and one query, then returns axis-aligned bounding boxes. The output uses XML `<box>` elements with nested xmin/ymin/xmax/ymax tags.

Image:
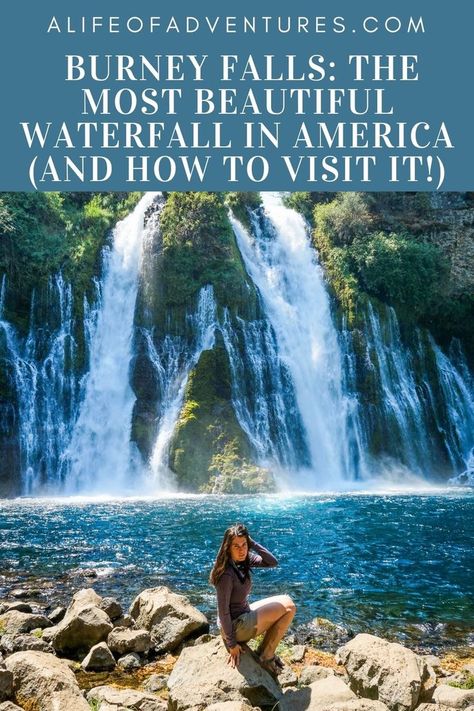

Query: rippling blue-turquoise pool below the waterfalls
<box><xmin>0</xmin><ymin>491</ymin><xmax>474</xmax><ymax>649</ymax></box>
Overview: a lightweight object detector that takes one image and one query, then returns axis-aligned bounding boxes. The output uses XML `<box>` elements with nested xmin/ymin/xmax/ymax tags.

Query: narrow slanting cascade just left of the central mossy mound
<box><xmin>144</xmin><ymin>286</ymin><xmax>217</xmax><ymax>492</ymax></box>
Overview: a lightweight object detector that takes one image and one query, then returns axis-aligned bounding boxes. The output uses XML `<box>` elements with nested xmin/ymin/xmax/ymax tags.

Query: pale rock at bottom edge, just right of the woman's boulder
<box><xmin>279</xmin><ymin>677</ymin><xmax>357</xmax><ymax>711</ymax></box>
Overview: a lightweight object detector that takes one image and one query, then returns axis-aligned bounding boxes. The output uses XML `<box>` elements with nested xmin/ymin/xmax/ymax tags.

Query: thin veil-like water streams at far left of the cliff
<box><xmin>0</xmin><ymin>274</ymin><xmax>78</xmax><ymax>494</ymax></box>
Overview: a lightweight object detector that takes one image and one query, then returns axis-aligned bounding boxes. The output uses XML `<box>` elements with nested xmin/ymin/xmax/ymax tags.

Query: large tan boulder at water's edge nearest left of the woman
<box><xmin>130</xmin><ymin>586</ymin><xmax>209</xmax><ymax>652</ymax></box>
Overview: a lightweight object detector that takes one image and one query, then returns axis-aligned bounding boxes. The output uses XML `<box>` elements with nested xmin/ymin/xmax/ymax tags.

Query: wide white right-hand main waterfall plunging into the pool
<box><xmin>233</xmin><ymin>193</ymin><xmax>352</xmax><ymax>488</ymax></box>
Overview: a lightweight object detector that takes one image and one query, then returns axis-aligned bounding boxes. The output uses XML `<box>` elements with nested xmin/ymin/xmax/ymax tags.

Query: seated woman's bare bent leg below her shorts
<box><xmin>250</xmin><ymin>595</ymin><xmax>296</xmax><ymax>660</ymax></box>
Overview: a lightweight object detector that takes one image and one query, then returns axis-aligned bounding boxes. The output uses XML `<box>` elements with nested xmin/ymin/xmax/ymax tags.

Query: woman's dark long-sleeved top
<box><xmin>216</xmin><ymin>539</ymin><xmax>278</xmax><ymax>647</ymax></box>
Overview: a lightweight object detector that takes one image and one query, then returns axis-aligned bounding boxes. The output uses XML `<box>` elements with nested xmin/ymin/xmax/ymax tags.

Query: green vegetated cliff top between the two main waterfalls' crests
<box><xmin>154</xmin><ymin>192</ymin><xmax>255</xmax><ymax>320</ymax></box>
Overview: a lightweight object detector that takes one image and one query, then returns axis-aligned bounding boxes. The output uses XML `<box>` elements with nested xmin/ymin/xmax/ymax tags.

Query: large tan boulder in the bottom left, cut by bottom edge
<box><xmin>5</xmin><ymin>652</ymin><xmax>90</xmax><ymax>711</ymax></box>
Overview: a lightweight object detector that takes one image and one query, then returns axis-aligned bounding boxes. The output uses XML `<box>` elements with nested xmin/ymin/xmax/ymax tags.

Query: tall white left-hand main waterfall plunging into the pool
<box><xmin>65</xmin><ymin>193</ymin><xmax>157</xmax><ymax>493</ymax></box>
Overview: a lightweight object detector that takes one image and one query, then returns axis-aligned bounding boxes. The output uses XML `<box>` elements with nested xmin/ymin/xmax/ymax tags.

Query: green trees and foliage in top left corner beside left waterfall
<box><xmin>0</xmin><ymin>193</ymin><xmax>140</xmax><ymax>328</ymax></box>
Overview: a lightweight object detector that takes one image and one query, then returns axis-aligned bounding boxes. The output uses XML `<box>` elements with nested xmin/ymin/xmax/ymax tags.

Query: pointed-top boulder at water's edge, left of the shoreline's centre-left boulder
<box><xmin>47</xmin><ymin>588</ymin><xmax>113</xmax><ymax>655</ymax></box>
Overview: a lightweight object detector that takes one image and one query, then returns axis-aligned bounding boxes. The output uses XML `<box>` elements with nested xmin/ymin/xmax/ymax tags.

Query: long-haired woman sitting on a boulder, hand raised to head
<box><xmin>210</xmin><ymin>523</ymin><xmax>296</xmax><ymax>675</ymax></box>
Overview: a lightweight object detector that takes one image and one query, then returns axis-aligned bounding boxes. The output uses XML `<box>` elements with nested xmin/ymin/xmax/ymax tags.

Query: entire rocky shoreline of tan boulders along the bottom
<box><xmin>0</xmin><ymin>586</ymin><xmax>474</xmax><ymax>711</ymax></box>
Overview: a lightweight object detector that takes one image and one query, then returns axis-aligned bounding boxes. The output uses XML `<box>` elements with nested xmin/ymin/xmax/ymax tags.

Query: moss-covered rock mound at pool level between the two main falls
<box><xmin>170</xmin><ymin>342</ymin><xmax>269</xmax><ymax>493</ymax></box>
